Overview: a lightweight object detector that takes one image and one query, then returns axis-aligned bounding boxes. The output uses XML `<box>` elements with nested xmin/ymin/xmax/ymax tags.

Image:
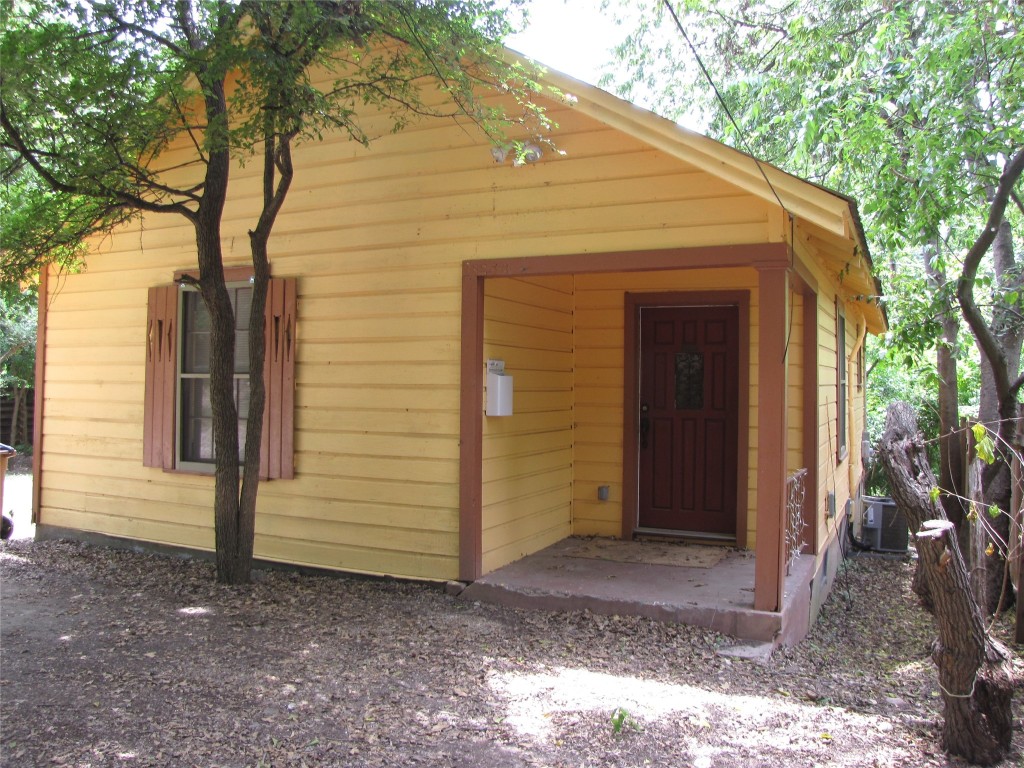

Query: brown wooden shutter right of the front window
<box><xmin>260</xmin><ymin>278</ymin><xmax>296</xmax><ymax>479</ymax></box>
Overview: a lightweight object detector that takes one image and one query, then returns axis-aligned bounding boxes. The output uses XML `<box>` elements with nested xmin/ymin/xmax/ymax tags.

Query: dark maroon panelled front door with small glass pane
<box><xmin>637</xmin><ymin>306</ymin><xmax>739</xmax><ymax>538</ymax></box>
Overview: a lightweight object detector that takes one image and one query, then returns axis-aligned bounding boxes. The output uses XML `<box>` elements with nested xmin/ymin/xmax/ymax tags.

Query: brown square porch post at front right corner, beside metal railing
<box><xmin>754</xmin><ymin>266</ymin><xmax>790</xmax><ymax>611</ymax></box>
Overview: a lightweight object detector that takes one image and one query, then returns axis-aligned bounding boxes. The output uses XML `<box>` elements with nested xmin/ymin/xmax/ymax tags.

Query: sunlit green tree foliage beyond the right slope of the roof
<box><xmin>606</xmin><ymin>0</ymin><xmax>1024</xmax><ymax>610</ymax></box>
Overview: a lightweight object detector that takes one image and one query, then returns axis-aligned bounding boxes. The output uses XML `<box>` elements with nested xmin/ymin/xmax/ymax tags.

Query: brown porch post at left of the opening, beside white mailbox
<box><xmin>459</xmin><ymin>262</ymin><xmax>483</xmax><ymax>582</ymax></box>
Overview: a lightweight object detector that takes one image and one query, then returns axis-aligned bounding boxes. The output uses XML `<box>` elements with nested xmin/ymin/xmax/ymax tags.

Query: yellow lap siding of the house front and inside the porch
<box><xmin>41</xmin><ymin>82</ymin><xmax>770</xmax><ymax>579</ymax></box>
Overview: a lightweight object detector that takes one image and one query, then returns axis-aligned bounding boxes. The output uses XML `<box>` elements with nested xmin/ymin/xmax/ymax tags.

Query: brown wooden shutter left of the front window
<box><xmin>142</xmin><ymin>285</ymin><xmax>178</xmax><ymax>469</ymax></box>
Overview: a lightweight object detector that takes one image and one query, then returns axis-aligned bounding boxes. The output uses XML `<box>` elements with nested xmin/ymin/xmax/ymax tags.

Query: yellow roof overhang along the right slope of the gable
<box><xmin>509</xmin><ymin>51</ymin><xmax>888</xmax><ymax>333</ymax></box>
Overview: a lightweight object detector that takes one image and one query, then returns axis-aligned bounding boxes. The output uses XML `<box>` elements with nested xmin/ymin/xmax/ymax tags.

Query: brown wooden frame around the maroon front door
<box><xmin>622</xmin><ymin>291</ymin><xmax>751</xmax><ymax>549</ymax></box>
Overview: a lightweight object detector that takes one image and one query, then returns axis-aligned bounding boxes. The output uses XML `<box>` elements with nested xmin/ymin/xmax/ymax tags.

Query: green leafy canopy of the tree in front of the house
<box><xmin>0</xmin><ymin>0</ymin><xmax>544</xmax><ymax>280</ymax></box>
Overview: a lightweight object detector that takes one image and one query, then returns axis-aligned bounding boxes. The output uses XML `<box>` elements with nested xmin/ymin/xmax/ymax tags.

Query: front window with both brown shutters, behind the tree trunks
<box><xmin>142</xmin><ymin>269</ymin><xmax>296</xmax><ymax>478</ymax></box>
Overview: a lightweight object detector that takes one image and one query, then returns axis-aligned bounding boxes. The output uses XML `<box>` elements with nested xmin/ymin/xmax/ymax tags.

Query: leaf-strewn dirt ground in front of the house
<box><xmin>0</xmin><ymin>528</ymin><xmax>1024</xmax><ymax>768</ymax></box>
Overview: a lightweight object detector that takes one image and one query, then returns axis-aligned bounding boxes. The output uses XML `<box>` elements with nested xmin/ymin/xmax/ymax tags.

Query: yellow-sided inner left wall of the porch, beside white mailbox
<box><xmin>481</xmin><ymin>276</ymin><xmax>572</xmax><ymax>572</ymax></box>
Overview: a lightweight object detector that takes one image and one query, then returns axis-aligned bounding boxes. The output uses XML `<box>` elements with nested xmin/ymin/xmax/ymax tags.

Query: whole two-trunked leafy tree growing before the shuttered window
<box><xmin>0</xmin><ymin>0</ymin><xmax>546</xmax><ymax>584</ymax></box>
